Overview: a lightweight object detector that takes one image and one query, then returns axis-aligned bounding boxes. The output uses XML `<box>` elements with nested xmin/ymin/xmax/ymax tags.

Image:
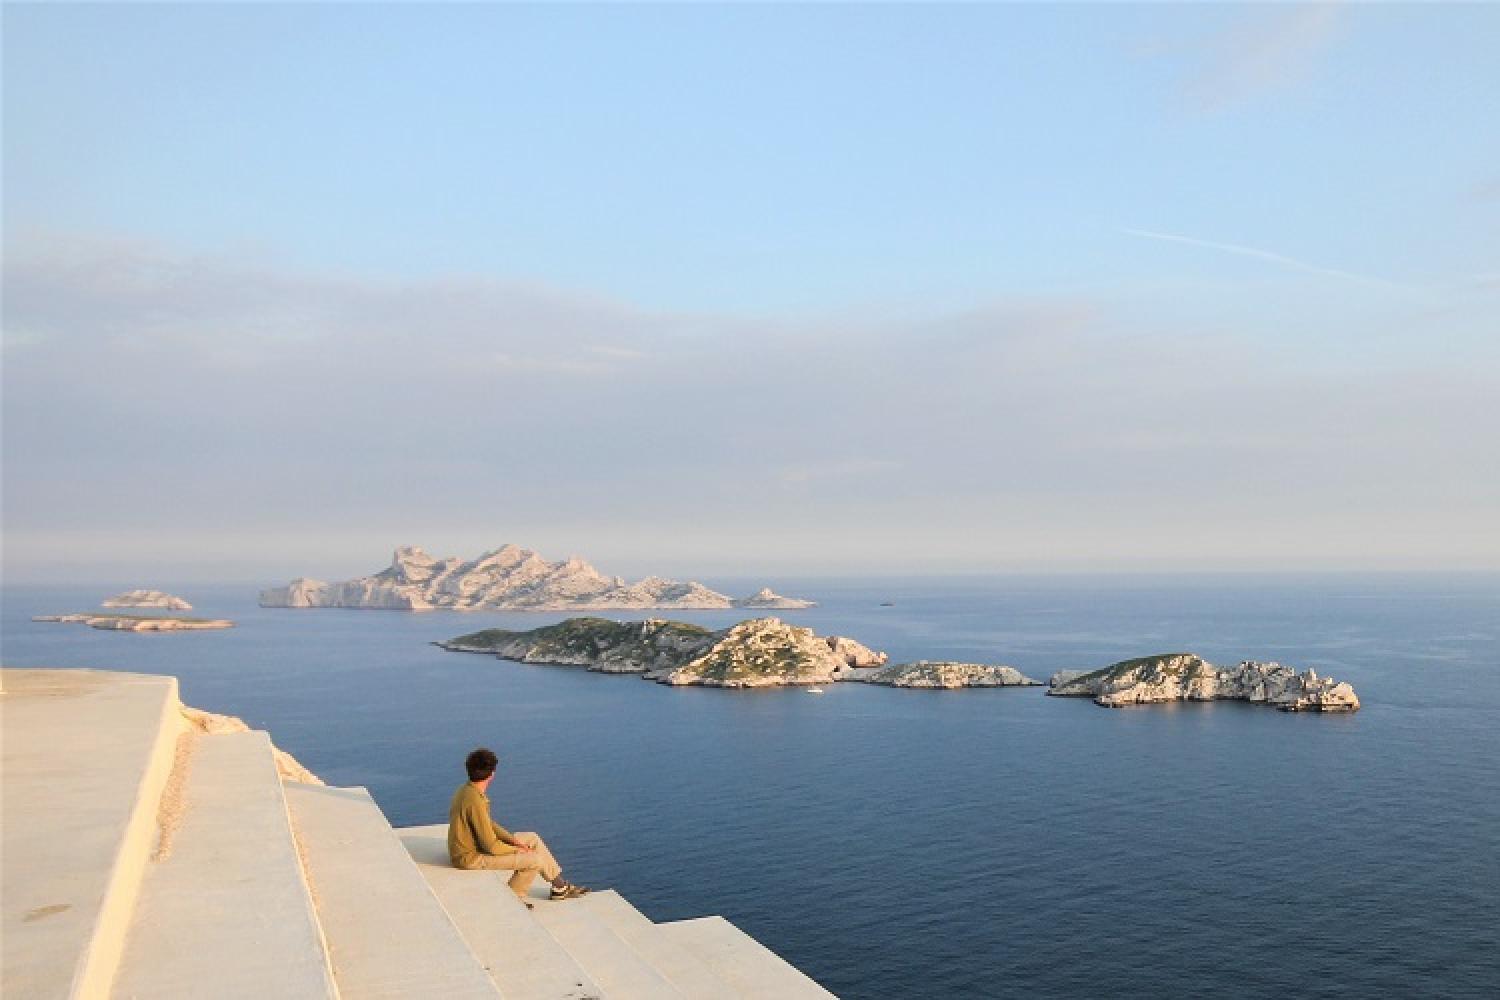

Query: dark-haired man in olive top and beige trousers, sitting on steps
<box><xmin>449</xmin><ymin>747</ymin><xmax>588</xmax><ymax>909</ymax></box>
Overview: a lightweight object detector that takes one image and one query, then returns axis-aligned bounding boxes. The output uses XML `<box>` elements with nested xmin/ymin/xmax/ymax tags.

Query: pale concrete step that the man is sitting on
<box><xmin>396</xmin><ymin>823</ymin><xmax>603</xmax><ymax>1000</ymax></box>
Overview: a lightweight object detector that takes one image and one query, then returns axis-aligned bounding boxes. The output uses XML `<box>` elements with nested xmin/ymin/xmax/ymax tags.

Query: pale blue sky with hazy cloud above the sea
<box><xmin>3</xmin><ymin>3</ymin><xmax>1500</xmax><ymax>586</ymax></box>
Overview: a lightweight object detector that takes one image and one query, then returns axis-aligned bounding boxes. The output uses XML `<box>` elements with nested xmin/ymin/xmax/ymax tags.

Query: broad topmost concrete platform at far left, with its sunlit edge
<box><xmin>0</xmin><ymin>669</ymin><xmax>186</xmax><ymax>1000</ymax></box>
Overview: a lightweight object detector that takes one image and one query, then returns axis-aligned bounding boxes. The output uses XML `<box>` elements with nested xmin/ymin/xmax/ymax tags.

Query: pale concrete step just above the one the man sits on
<box><xmin>285</xmin><ymin>784</ymin><xmax>500</xmax><ymax>1000</ymax></box>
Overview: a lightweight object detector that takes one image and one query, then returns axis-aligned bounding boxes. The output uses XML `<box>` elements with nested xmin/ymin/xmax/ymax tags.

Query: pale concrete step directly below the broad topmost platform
<box><xmin>114</xmin><ymin>732</ymin><xmax>338</xmax><ymax>1000</ymax></box>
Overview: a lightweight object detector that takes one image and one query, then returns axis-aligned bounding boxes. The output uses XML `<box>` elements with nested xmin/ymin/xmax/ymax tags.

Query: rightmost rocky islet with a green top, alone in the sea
<box><xmin>1047</xmin><ymin>652</ymin><xmax>1359</xmax><ymax>712</ymax></box>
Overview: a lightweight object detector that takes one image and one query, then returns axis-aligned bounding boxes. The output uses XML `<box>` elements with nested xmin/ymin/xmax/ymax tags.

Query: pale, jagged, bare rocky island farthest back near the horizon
<box><xmin>260</xmin><ymin>546</ymin><xmax>813</xmax><ymax>612</ymax></box>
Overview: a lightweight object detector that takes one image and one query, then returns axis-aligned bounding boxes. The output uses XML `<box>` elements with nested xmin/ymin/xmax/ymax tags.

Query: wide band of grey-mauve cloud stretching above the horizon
<box><xmin>3</xmin><ymin>223</ymin><xmax>1500</xmax><ymax>580</ymax></box>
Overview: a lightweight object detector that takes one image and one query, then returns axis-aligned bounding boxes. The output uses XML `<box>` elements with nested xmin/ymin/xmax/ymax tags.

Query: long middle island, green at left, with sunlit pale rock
<box><xmin>437</xmin><ymin>618</ymin><xmax>1037</xmax><ymax>688</ymax></box>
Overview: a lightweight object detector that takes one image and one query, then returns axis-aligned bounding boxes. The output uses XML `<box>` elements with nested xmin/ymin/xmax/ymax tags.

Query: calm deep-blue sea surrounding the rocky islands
<box><xmin>3</xmin><ymin>576</ymin><xmax>1500</xmax><ymax>997</ymax></box>
